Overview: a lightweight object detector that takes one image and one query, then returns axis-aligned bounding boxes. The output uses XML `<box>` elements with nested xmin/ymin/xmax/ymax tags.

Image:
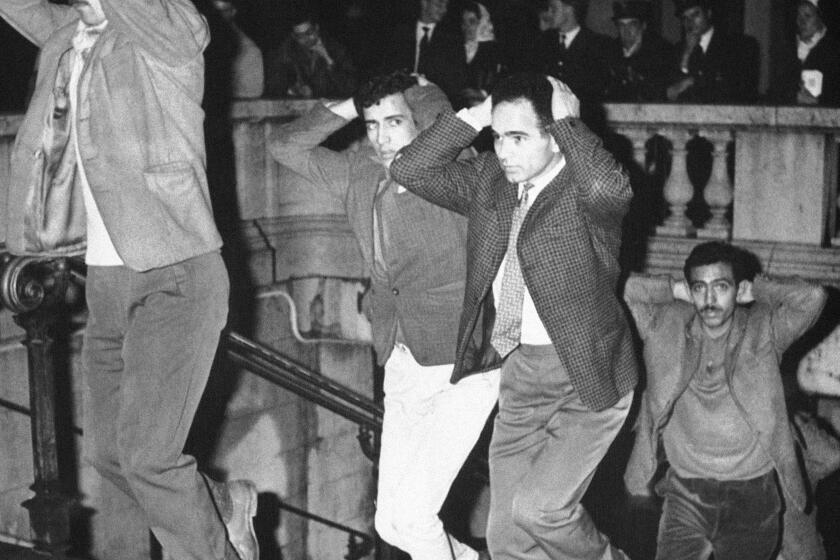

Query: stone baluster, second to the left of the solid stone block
<box><xmin>656</xmin><ymin>128</ymin><xmax>695</xmax><ymax>237</ymax></box>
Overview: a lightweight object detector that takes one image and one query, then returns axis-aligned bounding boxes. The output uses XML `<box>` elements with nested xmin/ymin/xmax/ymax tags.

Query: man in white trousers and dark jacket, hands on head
<box><xmin>270</xmin><ymin>72</ymin><xmax>499</xmax><ymax>560</ymax></box>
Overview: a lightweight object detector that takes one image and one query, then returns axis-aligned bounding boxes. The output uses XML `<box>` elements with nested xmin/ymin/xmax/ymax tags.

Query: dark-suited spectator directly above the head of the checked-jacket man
<box><xmin>531</xmin><ymin>0</ymin><xmax>610</xmax><ymax>106</ymax></box>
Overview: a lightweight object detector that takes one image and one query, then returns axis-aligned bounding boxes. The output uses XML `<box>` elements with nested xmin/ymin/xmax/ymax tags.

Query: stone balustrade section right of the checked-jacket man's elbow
<box><xmin>606</xmin><ymin>104</ymin><xmax>840</xmax><ymax>246</ymax></box>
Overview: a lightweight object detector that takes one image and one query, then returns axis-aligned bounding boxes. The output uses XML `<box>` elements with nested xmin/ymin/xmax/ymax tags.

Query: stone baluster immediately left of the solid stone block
<box><xmin>697</xmin><ymin>130</ymin><xmax>732</xmax><ymax>240</ymax></box>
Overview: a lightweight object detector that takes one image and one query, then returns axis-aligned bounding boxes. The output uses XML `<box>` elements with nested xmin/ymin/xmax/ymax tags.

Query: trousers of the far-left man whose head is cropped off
<box><xmin>82</xmin><ymin>253</ymin><xmax>229</xmax><ymax>560</ymax></box>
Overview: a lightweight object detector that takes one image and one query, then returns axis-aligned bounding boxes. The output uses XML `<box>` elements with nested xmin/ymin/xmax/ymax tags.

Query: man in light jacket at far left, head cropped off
<box><xmin>0</xmin><ymin>0</ymin><xmax>259</xmax><ymax>560</ymax></box>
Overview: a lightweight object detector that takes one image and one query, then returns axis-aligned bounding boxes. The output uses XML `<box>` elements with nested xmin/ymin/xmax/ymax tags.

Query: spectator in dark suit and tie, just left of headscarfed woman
<box><xmin>382</xmin><ymin>0</ymin><xmax>466</xmax><ymax>101</ymax></box>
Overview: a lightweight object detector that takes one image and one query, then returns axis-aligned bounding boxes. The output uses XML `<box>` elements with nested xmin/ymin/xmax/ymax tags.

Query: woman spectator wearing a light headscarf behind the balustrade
<box><xmin>459</xmin><ymin>2</ymin><xmax>505</xmax><ymax>107</ymax></box>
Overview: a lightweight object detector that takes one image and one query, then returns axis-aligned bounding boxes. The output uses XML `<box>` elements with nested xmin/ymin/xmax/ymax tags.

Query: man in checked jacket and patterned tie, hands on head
<box><xmin>391</xmin><ymin>74</ymin><xmax>637</xmax><ymax>560</ymax></box>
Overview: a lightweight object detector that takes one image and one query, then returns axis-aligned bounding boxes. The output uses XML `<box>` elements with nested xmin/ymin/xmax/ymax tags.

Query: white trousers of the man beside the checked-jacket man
<box><xmin>375</xmin><ymin>344</ymin><xmax>499</xmax><ymax>560</ymax></box>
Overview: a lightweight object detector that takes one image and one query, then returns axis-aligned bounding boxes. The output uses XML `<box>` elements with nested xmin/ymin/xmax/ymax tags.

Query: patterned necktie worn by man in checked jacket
<box><xmin>490</xmin><ymin>183</ymin><xmax>534</xmax><ymax>358</ymax></box>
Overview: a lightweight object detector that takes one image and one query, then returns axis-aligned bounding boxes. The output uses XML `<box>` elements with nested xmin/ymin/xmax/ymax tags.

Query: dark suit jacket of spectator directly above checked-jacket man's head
<box><xmin>531</xmin><ymin>27</ymin><xmax>610</xmax><ymax>102</ymax></box>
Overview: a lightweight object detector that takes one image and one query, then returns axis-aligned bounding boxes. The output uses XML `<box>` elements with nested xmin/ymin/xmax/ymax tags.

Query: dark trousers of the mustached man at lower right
<box><xmin>656</xmin><ymin>470</ymin><xmax>781</xmax><ymax>560</ymax></box>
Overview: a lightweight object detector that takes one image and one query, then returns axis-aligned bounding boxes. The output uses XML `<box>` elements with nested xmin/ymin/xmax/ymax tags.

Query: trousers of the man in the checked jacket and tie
<box><xmin>487</xmin><ymin>346</ymin><xmax>633</xmax><ymax>560</ymax></box>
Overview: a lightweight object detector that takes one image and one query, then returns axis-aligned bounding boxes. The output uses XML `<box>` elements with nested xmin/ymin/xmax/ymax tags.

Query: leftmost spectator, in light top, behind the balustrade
<box><xmin>213</xmin><ymin>0</ymin><xmax>264</xmax><ymax>99</ymax></box>
